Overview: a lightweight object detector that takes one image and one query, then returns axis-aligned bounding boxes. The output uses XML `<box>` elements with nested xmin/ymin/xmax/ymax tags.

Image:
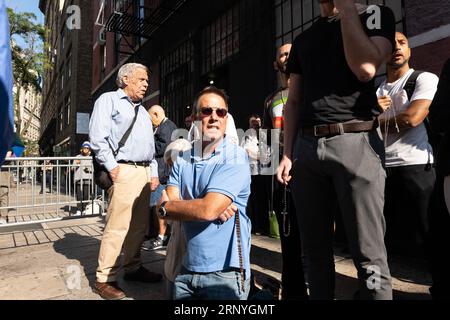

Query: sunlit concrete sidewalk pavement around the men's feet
<box><xmin>0</xmin><ymin>217</ymin><xmax>431</xmax><ymax>300</ymax></box>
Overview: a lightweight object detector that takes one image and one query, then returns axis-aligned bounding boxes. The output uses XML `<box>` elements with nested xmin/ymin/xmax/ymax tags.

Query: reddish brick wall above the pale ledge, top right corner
<box><xmin>405</xmin><ymin>0</ymin><xmax>450</xmax><ymax>37</ymax></box>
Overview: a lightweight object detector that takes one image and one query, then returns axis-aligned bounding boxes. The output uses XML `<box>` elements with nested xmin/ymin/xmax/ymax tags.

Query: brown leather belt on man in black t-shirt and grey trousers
<box><xmin>300</xmin><ymin>120</ymin><xmax>378</xmax><ymax>137</ymax></box>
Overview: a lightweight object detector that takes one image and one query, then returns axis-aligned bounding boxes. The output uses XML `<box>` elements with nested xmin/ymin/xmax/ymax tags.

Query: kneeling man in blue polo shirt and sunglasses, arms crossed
<box><xmin>158</xmin><ymin>87</ymin><xmax>251</xmax><ymax>300</ymax></box>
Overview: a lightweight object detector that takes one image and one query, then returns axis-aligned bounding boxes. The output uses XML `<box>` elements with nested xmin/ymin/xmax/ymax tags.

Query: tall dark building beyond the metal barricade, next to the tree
<box><xmin>39</xmin><ymin>0</ymin><xmax>92</xmax><ymax>156</ymax></box>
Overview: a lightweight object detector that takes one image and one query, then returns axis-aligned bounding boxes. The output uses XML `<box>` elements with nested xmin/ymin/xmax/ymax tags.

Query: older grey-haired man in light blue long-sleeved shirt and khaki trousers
<box><xmin>89</xmin><ymin>63</ymin><xmax>162</xmax><ymax>300</ymax></box>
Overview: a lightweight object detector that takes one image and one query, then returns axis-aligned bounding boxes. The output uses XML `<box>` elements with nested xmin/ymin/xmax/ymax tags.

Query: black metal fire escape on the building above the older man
<box><xmin>96</xmin><ymin>0</ymin><xmax>189</xmax><ymax>55</ymax></box>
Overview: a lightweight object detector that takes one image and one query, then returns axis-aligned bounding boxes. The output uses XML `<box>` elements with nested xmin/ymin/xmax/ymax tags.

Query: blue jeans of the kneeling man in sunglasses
<box><xmin>173</xmin><ymin>268</ymin><xmax>250</xmax><ymax>300</ymax></box>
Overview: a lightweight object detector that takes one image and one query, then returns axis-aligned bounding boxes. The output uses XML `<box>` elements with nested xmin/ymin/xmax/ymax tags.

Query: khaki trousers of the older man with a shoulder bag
<box><xmin>97</xmin><ymin>164</ymin><xmax>151</xmax><ymax>282</ymax></box>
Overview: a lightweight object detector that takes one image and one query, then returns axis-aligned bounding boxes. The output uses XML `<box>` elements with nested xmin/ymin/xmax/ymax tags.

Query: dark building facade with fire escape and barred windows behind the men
<box><xmin>92</xmin><ymin>0</ymin><xmax>450</xmax><ymax>129</ymax></box>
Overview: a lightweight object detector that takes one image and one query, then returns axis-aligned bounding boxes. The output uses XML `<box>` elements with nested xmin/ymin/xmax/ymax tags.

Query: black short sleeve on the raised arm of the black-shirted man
<box><xmin>364</xmin><ymin>6</ymin><xmax>395</xmax><ymax>50</ymax></box>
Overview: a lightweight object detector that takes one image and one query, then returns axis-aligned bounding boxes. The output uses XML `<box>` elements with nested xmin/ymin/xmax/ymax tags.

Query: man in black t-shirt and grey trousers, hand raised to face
<box><xmin>277</xmin><ymin>0</ymin><xmax>395</xmax><ymax>299</ymax></box>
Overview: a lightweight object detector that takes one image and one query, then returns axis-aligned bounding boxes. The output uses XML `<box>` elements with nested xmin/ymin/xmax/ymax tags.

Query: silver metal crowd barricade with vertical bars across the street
<box><xmin>0</xmin><ymin>157</ymin><xmax>107</xmax><ymax>226</ymax></box>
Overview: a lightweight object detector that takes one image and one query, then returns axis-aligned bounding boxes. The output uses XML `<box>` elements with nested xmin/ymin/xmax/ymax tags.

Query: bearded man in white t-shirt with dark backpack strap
<box><xmin>377</xmin><ymin>32</ymin><xmax>439</xmax><ymax>256</ymax></box>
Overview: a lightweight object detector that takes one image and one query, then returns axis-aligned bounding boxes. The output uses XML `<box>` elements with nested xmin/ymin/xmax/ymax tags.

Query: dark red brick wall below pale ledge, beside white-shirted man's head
<box><xmin>410</xmin><ymin>36</ymin><xmax>450</xmax><ymax>76</ymax></box>
